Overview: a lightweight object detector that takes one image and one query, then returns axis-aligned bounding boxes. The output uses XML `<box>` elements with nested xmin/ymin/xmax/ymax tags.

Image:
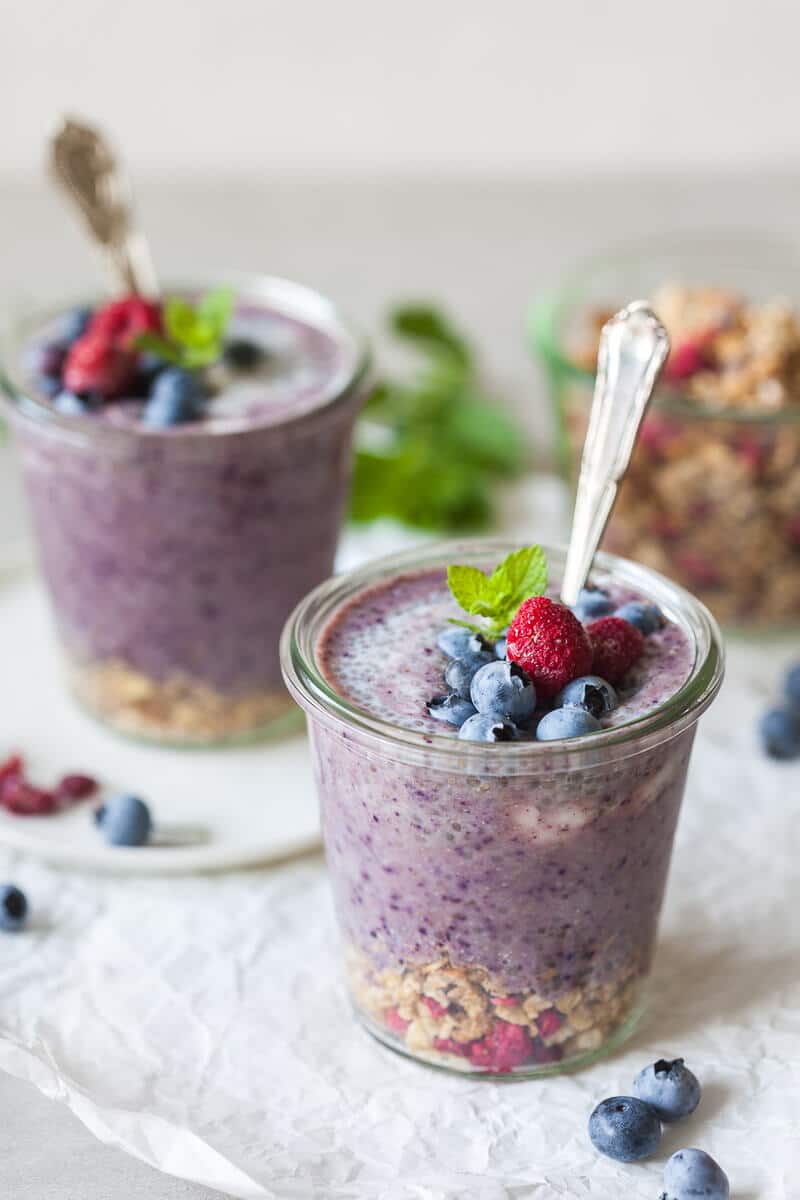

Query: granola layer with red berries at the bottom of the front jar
<box><xmin>347</xmin><ymin>948</ymin><xmax>642</xmax><ymax>1074</ymax></box>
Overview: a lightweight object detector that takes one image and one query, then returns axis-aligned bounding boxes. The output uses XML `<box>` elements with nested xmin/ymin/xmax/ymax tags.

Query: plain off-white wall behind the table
<box><xmin>0</xmin><ymin>0</ymin><xmax>800</xmax><ymax>173</ymax></box>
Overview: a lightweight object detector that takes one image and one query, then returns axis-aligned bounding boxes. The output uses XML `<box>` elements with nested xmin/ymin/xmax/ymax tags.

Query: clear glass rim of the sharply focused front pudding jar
<box><xmin>281</xmin><ymin>539</ymin><xmax>724</xmax><ymax>775</ymax></box>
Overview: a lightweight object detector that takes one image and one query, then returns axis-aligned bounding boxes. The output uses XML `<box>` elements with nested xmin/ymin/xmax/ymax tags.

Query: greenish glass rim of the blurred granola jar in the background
<box><xmin>527</xmin><ymin>233</ymin><xmax>800</xmax><ymax>427</ymax></box>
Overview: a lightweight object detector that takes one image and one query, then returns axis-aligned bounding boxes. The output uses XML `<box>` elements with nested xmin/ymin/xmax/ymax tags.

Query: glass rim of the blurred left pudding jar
<box><xmin>0</xmin><ymin>271</ymin><xmax>372</xmax><ymax>443</ymax></box>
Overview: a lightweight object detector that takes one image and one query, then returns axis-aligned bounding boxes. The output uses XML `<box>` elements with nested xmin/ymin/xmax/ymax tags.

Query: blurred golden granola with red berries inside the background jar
<box><xmin>564</xmin><ymin>286</ymin><xmax>800</xmax><ymax>625</ymax></box>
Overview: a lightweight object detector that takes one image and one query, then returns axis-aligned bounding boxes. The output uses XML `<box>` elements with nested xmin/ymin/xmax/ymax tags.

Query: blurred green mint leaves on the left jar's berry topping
<box><xmin>136</xmin><ymin>288</ymin><xmax>234</xmax><ymax>371</ymax></box>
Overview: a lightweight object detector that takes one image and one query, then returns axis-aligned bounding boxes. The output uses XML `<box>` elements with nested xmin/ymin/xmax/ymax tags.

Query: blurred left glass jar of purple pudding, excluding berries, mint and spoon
<box><xmin>4</xmin><ymin>280</ymin><xmax>365</xmax><ymax>744</ymax></box>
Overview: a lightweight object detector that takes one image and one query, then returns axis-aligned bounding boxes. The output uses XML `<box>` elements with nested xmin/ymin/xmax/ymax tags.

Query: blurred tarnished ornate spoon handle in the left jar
<box><xmin>50</xmin><ymin>119</ymin><xmax>158</xmax><ymax>295</ymax></box>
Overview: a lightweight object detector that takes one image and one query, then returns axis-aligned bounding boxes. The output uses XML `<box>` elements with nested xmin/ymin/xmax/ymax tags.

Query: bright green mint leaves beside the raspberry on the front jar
<box><xmin>447</xmin><ymin>546</ymin><xmax>547</xmax><ymax>638</ymax></box>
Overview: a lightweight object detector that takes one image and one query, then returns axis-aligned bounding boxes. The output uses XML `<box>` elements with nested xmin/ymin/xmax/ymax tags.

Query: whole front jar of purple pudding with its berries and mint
<box><xmin>284</xmin><ymin>547</ymin><xmax>718</xmax><ymax>1074</ymax></box>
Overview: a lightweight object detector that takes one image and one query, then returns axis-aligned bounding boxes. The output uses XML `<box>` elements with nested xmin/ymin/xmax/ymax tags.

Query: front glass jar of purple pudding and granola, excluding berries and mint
<box><xmin>283</xmin><ymin>542</ymin><xmax>722</xmax><ymax>1074</ymax></box>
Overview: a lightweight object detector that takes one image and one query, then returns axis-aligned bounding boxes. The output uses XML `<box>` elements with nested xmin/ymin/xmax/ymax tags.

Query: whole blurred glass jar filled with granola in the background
<box><xmin>530</xmin><ymin>234</ymin><xmax>800</xmax><ymax>630</ymax></box>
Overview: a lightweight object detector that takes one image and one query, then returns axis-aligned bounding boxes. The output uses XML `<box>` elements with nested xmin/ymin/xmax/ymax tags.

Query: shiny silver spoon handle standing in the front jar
<box><xmin>561</xmin><ymin>300</ymin><xmax>669</xmax><ymax>606</ymax></box>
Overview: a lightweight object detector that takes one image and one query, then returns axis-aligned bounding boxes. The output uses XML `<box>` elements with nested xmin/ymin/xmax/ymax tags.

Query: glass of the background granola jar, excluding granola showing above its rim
<box><xmin>530</xmin><ymin>235</ymin><xmax>800</xmax><ymax>630</ymax></box>
